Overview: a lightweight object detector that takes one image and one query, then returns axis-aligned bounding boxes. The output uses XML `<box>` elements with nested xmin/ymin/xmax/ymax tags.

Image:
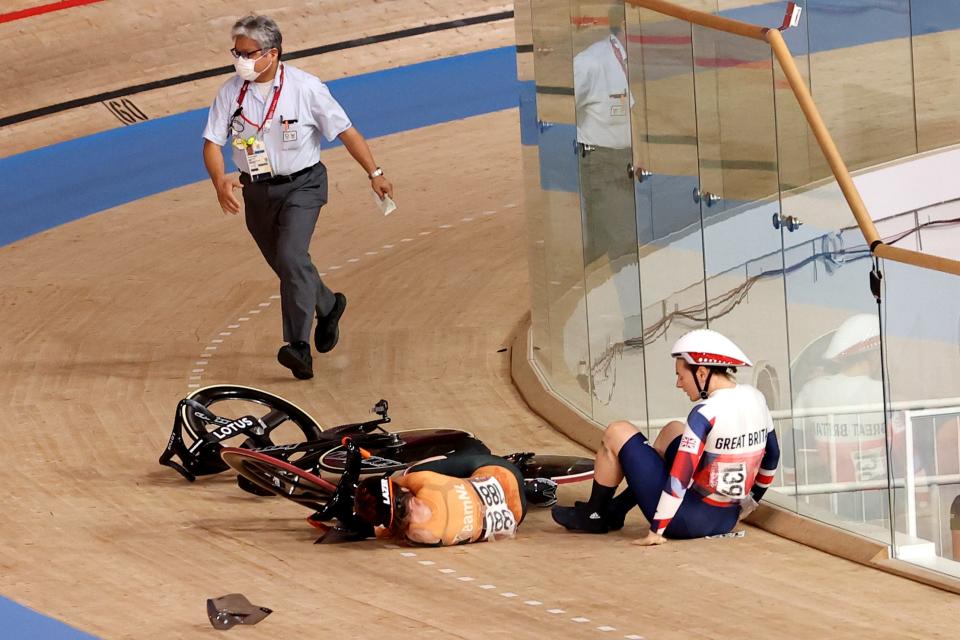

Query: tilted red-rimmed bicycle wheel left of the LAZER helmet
<box><xmin>220</xmin><ymin>447</ymin><xmax>337</xmax><ymax>511</ymax></box>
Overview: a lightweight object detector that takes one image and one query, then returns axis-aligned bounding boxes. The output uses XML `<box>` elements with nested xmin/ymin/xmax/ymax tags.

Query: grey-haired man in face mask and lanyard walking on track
<box><xmin>203</xmin><ymin>16</ymin><xmax>393</xmax><ymax>379</ymax></box>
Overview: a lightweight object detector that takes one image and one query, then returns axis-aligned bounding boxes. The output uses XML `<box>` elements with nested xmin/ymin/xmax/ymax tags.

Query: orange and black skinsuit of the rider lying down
<box><xmin>394</xmin><ymin>454</ymin><xmax>527</xmax><ymax>546</ymax></box>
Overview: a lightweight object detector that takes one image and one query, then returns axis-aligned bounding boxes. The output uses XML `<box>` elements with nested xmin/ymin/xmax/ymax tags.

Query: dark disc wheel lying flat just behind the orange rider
<box><xmin>316</xmin><ymin>429</ymin><xmax>490</xmax><ymax>475</ymax></box>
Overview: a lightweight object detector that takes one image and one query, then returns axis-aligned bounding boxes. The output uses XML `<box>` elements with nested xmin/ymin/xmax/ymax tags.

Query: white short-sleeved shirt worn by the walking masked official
<box><xmin>203</xmin><ymin>63</ymin><xmax>352</xmax><ymax>176</ymax></box>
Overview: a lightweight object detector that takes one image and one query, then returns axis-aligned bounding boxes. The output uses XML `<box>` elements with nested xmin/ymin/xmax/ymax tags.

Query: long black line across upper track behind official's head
<box><xmin>0</xmin><ymin>11</ymin><xmax>513</xmax><ymax>127</ymax></box>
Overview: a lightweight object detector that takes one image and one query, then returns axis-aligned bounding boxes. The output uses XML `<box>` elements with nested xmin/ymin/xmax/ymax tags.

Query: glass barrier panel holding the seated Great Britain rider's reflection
<box><xmin>782</xmin><ymin>180</ymin><xmax>891</xmax><ymax>544</ymax></box>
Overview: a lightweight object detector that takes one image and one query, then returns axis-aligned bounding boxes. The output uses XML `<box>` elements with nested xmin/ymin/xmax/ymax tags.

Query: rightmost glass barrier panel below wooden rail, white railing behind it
<box><xmin>881</xmin><ymin>256</ymin><xmax>960</xmax><ymax>575</ymax></box>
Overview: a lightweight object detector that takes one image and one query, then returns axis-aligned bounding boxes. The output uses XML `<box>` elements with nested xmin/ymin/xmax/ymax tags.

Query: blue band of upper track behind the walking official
<box><xmin>0</xmin><ymin>47</ymin><xmax>519</xmax><ymax>246</ymax></box>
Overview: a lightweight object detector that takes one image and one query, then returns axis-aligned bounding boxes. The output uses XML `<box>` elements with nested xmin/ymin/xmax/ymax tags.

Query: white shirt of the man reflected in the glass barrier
<box><xmin>573</xmin><ymin>35</ymin><xmax>633</xmax><ymax>149</ymax></box>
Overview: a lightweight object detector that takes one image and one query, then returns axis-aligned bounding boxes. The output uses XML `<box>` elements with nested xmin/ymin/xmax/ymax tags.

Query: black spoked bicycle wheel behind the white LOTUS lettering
<box><xmin>179</xmin><ymin>384</ymin><xmax>323</xmax><ymax>447</ymax></box>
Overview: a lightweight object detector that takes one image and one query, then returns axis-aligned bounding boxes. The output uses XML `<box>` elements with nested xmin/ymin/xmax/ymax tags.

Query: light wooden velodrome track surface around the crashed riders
<box><xmin>0</xmin><ymin>0</ymin><xmax>960</xmax><ymax>639</ymax></box>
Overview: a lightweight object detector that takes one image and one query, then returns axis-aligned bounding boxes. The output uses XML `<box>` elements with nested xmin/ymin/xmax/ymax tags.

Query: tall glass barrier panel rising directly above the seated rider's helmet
<box><xmin>693</xmin><ymin>27</ymin><xmax>790</xmax><ymax>411</ymax></box>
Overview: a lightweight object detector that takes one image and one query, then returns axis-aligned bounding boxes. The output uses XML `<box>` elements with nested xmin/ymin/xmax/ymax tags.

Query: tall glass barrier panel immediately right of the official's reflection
<box><xmin>623</xmin><ymin>9</ymin><xmax>704</xmax><ymax>437</ymax></box>
